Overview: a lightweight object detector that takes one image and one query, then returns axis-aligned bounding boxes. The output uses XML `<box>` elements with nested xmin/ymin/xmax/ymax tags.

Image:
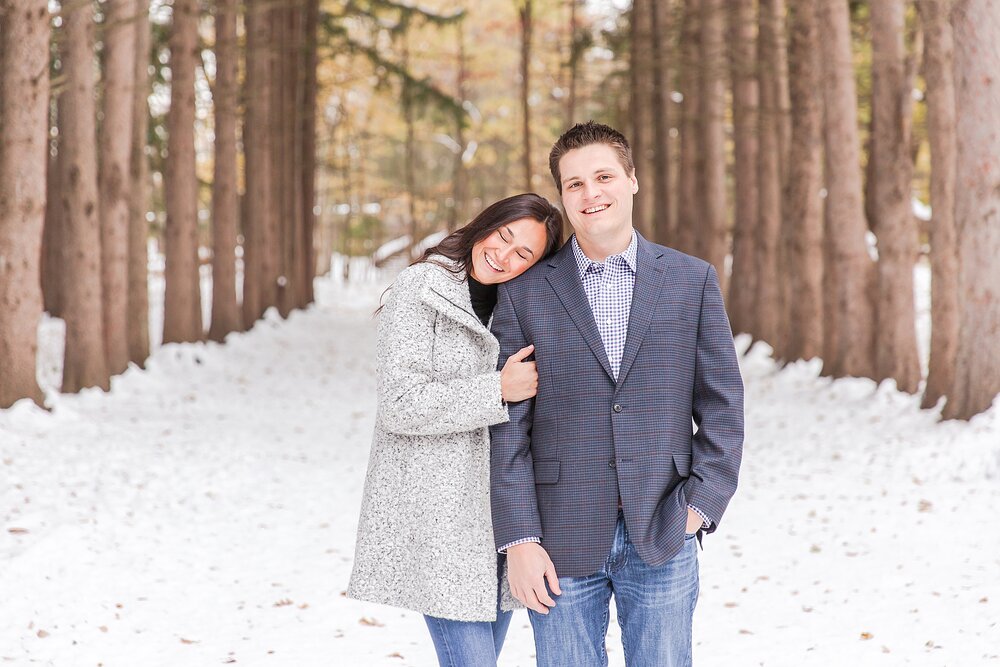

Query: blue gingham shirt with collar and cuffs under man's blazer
<box><xmin>500</xmin><ymin>230</ymin><xmax>711</xmax><ymax>552</ymax></box>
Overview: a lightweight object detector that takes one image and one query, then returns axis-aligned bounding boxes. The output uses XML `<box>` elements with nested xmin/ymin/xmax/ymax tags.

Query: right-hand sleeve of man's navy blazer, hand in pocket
<box><xmin>684</xmin><ymin>266</ymin><xmax>743</xmax><ymax>532</ymax></box>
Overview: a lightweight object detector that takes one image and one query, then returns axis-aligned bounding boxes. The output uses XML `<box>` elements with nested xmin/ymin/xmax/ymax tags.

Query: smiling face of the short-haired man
<box><xmin>559</xmin><ymin>144</ymin><xmax>639</xmax><ymax>237</ymax></box>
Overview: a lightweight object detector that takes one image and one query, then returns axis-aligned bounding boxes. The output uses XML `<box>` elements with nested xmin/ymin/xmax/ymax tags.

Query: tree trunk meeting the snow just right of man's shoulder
<box><xmin>728</xmin><ymin>0</ymin><xmax>759</xmax><ymax>334</ymax></box>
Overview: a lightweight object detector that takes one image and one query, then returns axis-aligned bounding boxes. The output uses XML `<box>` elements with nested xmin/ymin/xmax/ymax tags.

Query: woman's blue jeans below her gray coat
<box><xmin>424</xmin><ymin>556</ymin><xmax>513</xmax><ymax>667</ymax></box>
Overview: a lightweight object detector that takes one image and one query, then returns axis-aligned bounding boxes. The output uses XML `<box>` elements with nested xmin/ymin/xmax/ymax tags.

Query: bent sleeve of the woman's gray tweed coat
<box><xmin>377</xmin><ymin>274</ymin><xmax>508</xmax><ymax>435</ymax></box>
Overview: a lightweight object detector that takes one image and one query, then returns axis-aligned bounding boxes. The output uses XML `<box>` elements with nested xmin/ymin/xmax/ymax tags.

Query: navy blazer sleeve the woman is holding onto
<box><xmin>490</xmin><ymin>285</ymin><xmax>544</xmax><ymax>549</ymax></box>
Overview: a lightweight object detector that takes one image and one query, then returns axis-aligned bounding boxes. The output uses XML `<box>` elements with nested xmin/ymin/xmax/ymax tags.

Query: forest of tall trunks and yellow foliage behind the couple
<box><xmin>0</xmin><ymin>0</ymin><xmax>1000</xmax><ymax>418</ymax></box>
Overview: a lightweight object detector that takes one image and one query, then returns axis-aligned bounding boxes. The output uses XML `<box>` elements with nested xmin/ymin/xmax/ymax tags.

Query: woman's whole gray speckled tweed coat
<box><xmin>347</xmin><ymin>258</ymin><xmax>513</xmax><ymax>621</ymax></box>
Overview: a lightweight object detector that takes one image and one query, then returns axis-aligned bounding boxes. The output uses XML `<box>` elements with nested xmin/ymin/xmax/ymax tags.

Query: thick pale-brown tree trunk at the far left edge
<box><xmin>0</xmin><ymin>0</ymin><xmax>49</xmax><ymax>409</ymax></box>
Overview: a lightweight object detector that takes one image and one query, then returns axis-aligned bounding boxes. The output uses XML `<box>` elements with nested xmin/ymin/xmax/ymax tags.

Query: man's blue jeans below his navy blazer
<box><xmin>528</xmin><ymin>511</ymin><xmax>698</xmax><ymax>667</ymax></box>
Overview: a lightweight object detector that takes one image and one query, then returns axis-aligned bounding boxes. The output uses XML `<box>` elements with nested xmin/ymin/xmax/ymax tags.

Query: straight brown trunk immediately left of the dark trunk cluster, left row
<box><xmin>208</xmin><ymin>0</ymin><xmax>242</xmax><ymax>342</ymax></box>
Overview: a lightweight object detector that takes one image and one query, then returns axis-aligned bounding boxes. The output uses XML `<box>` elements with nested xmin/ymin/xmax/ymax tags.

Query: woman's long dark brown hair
<box><xmin>413</xmin><ymin>192</ymin><xmax>563</xmax><ymax>273</ymax></box>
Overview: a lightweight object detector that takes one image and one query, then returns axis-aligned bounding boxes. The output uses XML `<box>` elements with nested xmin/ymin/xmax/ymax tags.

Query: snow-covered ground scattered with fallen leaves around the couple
<box><xmin>0</xmin><ymin>264</ymin><xmax>1000</xmax><ymax>667</ymax></box>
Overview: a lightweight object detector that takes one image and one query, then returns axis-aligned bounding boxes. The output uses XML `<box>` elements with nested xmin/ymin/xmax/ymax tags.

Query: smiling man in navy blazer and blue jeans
<box><xmin>491</xmin><ymin>122</ymin><xmax>743</xmax><ymax>667</ymax></box>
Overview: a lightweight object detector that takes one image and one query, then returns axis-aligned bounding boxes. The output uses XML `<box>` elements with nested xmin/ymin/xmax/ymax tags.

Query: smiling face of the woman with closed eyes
<box><xmin>469</xmin><ymin>218</ymin><xmax>546</xmax><ymax>285</ymax></box>
